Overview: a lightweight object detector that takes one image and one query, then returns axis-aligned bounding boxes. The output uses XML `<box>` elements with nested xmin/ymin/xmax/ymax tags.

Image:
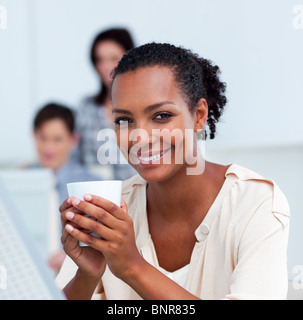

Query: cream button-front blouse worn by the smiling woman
<box><xmin>57</xmin><ymin>164</ymin><xmax>290</xmax><ymax>300</ymax></box>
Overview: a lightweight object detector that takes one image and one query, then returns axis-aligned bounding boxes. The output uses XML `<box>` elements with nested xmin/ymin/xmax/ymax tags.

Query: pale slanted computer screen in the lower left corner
<box><xmin>0</xmin><ymin>180</ymin><xmax>65</xmax><ymax>300</ymax></box>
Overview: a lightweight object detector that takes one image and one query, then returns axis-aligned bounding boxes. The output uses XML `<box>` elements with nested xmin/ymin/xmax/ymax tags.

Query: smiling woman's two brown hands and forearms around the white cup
<box><xmin>61</xmin><ymin>195</ymin><xmax>201</xmax><ymax>299</ymax></box>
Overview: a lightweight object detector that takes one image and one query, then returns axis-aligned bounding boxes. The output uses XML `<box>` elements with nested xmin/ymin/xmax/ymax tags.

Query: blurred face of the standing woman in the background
<box><xmin>95</xmin><ymin>40</ymin><xmax>125</xmax><ymax>88</ymax></box>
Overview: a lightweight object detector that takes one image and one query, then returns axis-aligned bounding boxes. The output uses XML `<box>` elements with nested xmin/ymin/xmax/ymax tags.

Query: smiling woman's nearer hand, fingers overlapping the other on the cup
<box><xmin>65</xmin><ymin>195</ymin><xmax>142</xmax><ymax>280</ymax></box>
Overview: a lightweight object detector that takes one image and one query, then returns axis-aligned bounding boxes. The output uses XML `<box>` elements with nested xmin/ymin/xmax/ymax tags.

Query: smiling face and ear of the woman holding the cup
<box><xmin>112</xmin><ymin>66</ymin><xmax>207</xmax><ymax>182</ymax></box>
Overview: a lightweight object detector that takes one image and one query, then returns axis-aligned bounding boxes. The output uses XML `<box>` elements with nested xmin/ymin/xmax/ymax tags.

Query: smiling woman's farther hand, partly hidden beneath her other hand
<box><xmin>60</xmin><ymin>197</ymin><xmax>106</xmax><ymax>280</ymax></box>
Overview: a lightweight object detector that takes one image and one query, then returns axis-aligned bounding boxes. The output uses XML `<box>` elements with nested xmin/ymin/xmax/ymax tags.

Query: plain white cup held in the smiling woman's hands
<box><xmin>67</xmin><ymin>180</ymin><xmax>122</xmax><ymax>246</ymax></box>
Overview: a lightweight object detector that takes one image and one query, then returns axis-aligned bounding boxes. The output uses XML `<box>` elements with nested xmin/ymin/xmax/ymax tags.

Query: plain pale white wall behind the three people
<box><xmin>0</xmin><ymin>0</ymin><xmax>303</xmax><ymax>280</ymax></box>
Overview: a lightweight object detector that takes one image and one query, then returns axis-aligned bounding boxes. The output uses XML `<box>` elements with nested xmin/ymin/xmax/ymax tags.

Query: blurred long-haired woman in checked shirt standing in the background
<box><xmin>75</xmin><ymin>29</ymin><xmax>135</xmax><ymax>180</ymax></box>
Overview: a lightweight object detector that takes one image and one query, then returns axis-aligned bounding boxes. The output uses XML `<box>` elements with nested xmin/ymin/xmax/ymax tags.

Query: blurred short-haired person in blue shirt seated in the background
<box><xmin>32</xmin><ymin>103</ymin><xmax>97</xmax><ymax>272</ymax></box>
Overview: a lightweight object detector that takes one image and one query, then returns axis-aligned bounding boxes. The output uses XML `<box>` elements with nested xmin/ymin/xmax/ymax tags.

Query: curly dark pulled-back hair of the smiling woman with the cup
<box><xmin>113</xmin><ymin>42</ymin><xmax>227</xmax><ymax>139</ymax></box>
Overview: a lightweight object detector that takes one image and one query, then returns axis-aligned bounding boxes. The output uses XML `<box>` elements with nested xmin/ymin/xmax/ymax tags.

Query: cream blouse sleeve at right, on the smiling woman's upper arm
<box><xmin>226</xmin><ymin>192</ymin><xmax>289</xmax><ymax>300</ymax></box>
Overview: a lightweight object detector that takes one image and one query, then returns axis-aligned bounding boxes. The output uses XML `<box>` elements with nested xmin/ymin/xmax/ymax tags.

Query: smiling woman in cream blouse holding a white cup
<box><xmin>58</xmin><ymin>43</ymin><xmax>289</xmax><ymax>299</ymax></box>
